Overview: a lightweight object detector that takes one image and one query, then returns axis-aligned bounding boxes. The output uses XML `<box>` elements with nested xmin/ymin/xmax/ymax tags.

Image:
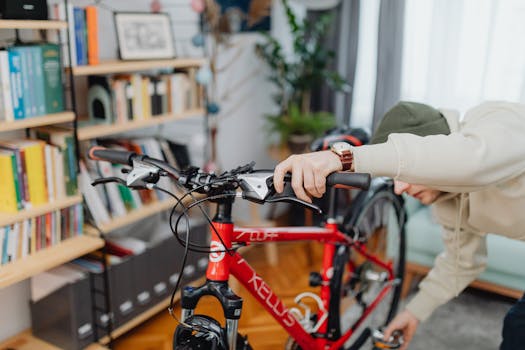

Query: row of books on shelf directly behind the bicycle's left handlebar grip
<box><xmin>79</xmin><ymin>138</ymin><xmax>187</xmax><ymax>225</ymax></box>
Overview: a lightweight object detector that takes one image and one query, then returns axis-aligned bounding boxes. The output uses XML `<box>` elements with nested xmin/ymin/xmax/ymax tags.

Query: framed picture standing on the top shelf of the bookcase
<box><xmin>115</xmin><ymin>12</ymin><xmax>175</xmax><ymax>60</ymax></box>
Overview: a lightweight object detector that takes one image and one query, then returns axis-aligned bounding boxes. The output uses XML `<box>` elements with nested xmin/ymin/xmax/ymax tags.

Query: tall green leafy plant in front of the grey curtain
<box><xmin>256</xmin><ymin>0</ymin><xmax>349</xmax><ymax>150</ymax></box>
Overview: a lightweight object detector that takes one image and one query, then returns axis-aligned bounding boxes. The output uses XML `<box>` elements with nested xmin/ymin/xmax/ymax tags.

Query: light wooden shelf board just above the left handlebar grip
<box><xmin>78</xmin><ymin>109</ymin><xmax>204</xmax><ymax>141</ymax></box>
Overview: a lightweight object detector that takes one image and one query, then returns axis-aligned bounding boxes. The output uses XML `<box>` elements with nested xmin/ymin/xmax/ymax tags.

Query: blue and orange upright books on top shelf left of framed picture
<box><xmin>48</xmin><ymin>2</ymin><xmax>99</xmax><ymax>67</ymax></box>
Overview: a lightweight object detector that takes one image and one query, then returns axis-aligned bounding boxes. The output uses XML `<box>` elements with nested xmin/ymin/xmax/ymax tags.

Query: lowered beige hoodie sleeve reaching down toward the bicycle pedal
<box><xmin>406</xmin><ymin>229</ymin><xmax>487</xmax><ymax>321</ymax></box>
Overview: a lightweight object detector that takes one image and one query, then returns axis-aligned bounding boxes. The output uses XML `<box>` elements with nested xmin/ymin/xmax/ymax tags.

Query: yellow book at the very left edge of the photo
<box><xmin>0</xmin><ymin>150</ymin><xmax>18</xmax><ymax>213</ymax></box>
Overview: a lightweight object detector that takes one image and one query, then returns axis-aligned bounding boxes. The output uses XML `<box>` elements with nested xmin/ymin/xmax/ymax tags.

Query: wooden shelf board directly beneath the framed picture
<box><xmin>72</xmin><ymin>58</ymin><xmax>206</xmax><ymax>76</ymax></box>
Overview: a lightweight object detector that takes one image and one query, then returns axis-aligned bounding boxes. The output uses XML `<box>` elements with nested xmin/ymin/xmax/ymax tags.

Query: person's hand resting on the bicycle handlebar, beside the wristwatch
<box><xmin>273</xmin><ymin>151</ymin><xmax>343</xmax><ymax>203</ymax></box>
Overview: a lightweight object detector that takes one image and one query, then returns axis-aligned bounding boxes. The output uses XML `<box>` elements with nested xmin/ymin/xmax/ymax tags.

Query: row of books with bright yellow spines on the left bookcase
<box><xmin>0</xmin><ymin>126</ymin><xmax>78</xmax><ymax>213</ymax></box>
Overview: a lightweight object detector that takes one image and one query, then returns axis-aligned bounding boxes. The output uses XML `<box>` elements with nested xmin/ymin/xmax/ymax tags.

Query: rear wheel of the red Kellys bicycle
<box><xmin>328</xmin><ymin>178</ymin><xmax>406</xmax><ymax>350</ymax></box>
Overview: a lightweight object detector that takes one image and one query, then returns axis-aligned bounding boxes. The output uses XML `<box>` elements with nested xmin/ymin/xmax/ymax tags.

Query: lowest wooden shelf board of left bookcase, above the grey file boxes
<box><xmin>0</xmin><ymin>235</ymin><xmax>104</xmax><ymax>288</ymax></box>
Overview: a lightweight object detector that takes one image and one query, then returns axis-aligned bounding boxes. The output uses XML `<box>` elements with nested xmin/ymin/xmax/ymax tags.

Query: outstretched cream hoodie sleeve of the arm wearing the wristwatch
<box><xmin>353</xmin><ymin>103</ymin><xmax>525</xmax><ymax>192</ymax></box>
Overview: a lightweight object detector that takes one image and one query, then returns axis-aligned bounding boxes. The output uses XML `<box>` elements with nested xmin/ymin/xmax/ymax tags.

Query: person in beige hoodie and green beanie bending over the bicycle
<box><xmin>274</xmin><ymin>102</ymin><xmax>525</xmax><ymax>350</ymax></box>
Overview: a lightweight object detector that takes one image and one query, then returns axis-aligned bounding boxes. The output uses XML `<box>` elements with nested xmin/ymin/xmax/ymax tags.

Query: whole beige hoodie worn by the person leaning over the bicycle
<box><xmin>353</xmin><ymin>102</ymin><xmax>525</xmax><ymax>320</ymax></box>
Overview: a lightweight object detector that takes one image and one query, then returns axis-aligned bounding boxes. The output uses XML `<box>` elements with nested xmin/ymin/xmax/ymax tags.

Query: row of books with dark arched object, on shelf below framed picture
<box><xmin>88</xmin><ymin>73</ymin><xmax>199</xmax><ymax>123</ymax></box>
